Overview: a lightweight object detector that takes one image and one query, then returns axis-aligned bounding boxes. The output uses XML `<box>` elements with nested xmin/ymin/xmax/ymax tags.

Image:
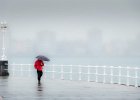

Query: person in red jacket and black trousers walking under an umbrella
<box><xmin>34</xmin><ymin>59</ymin><xmax>44</xmax><ymax>84</ymax></box>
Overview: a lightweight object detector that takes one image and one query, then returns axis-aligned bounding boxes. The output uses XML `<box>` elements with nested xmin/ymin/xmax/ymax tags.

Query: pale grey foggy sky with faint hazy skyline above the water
<box><xmin>0</xmin><ymin>0</ymin><xmax>140</xmax><ymax>57</ymax></box>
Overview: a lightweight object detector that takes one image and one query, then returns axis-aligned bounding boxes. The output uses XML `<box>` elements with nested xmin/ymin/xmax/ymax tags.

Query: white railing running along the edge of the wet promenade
<box><xmin>9</xmin><ymin>64</ymin><xmax>140</xmax><ymax>87</ymax></box>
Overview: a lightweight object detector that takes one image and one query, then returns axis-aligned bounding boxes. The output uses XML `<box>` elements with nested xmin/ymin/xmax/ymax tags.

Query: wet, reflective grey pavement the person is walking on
<box><xmin>0</xmin><ymin>76</ymin><xmax>140</xmax><ymax>100</ymax></box>
